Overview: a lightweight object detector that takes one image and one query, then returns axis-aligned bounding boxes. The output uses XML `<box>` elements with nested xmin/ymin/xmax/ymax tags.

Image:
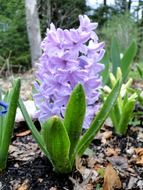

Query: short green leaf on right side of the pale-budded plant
<box><xmin>114</xmin><ymin>100</ymin><xmax>135</xmax><ymax>135</ymax></box>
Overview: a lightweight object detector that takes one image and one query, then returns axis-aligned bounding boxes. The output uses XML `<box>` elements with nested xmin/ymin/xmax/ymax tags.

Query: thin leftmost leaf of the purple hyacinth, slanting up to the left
<box><xmin>18</xmin><ymin>98</ymin><xmax>50</xmax><ymax>159</ymax></box>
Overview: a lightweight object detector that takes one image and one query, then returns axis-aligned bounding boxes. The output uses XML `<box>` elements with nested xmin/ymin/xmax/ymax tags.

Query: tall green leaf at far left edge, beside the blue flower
<box><xmin>0</xmin><ymin>79</ymin><xmax>21</xmax><ymax>170</ymax></box>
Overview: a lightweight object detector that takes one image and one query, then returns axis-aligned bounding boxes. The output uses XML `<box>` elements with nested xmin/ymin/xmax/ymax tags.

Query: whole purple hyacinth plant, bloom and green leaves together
<box><xmin>19</xmin><ymin>15</ymin><xmax>121</xmax><ymax>173</ymax></box>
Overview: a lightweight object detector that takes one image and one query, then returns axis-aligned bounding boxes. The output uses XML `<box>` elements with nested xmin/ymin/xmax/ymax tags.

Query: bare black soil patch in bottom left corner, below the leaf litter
<box><xmin>0</xmin><ymin>154</ymin><xmax>72</xmax><ymax>190</ymax></box>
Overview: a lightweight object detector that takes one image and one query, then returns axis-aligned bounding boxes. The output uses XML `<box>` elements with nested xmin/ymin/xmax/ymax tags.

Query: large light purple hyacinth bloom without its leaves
<box><xmin>33</xmin><ymin>15</ymin><xmax>104</xmax><ymax>128</ymax></box>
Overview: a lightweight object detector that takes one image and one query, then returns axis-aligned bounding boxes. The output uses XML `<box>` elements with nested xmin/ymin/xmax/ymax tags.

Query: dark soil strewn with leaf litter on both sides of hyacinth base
<box><xmin>0</xmin><ymin>116</ymin><xmax>143</xmax><ymax>190</ymax></box>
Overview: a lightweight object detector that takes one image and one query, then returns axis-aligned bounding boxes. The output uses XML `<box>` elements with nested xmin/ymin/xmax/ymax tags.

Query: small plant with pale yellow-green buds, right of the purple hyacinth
<box><xmin>104</xmin><ymin>68</ymin><xmax>138</xmax><ymax>135</ymax></box>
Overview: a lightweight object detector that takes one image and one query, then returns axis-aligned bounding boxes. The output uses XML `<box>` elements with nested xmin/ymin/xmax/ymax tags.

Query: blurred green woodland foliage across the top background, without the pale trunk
<box><xmin>0</xmin><ymin>0</ymin><xmax>143</xmax><ymax>70</ymax></box>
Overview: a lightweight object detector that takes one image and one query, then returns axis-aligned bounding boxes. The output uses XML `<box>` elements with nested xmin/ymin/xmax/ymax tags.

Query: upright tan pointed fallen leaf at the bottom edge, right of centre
<box><xmin>103</xmin><ymin>163</ymin><xmax>122</xmax><ymax>190</ymax></box>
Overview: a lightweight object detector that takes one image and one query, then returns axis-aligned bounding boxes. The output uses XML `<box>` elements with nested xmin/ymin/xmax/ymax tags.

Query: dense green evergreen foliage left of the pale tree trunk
<box><xmin>0</xmin><ymin>0</ymin><xmax>30</xmax><ymax>70</ymax></box>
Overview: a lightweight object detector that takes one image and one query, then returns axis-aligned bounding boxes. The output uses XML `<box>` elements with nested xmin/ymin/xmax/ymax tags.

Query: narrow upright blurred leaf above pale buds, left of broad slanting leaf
<box><xmin>110</xmin><ymin>38</ymin><xmax>121</xmax><ymax>75</ymax></box>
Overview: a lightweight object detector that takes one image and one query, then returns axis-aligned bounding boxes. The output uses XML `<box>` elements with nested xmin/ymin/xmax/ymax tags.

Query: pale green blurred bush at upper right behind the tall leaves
<box><xmin>100</xmin><ymin>13</ymin><xmax>138</xmax><ymax>53</ymax></box>
